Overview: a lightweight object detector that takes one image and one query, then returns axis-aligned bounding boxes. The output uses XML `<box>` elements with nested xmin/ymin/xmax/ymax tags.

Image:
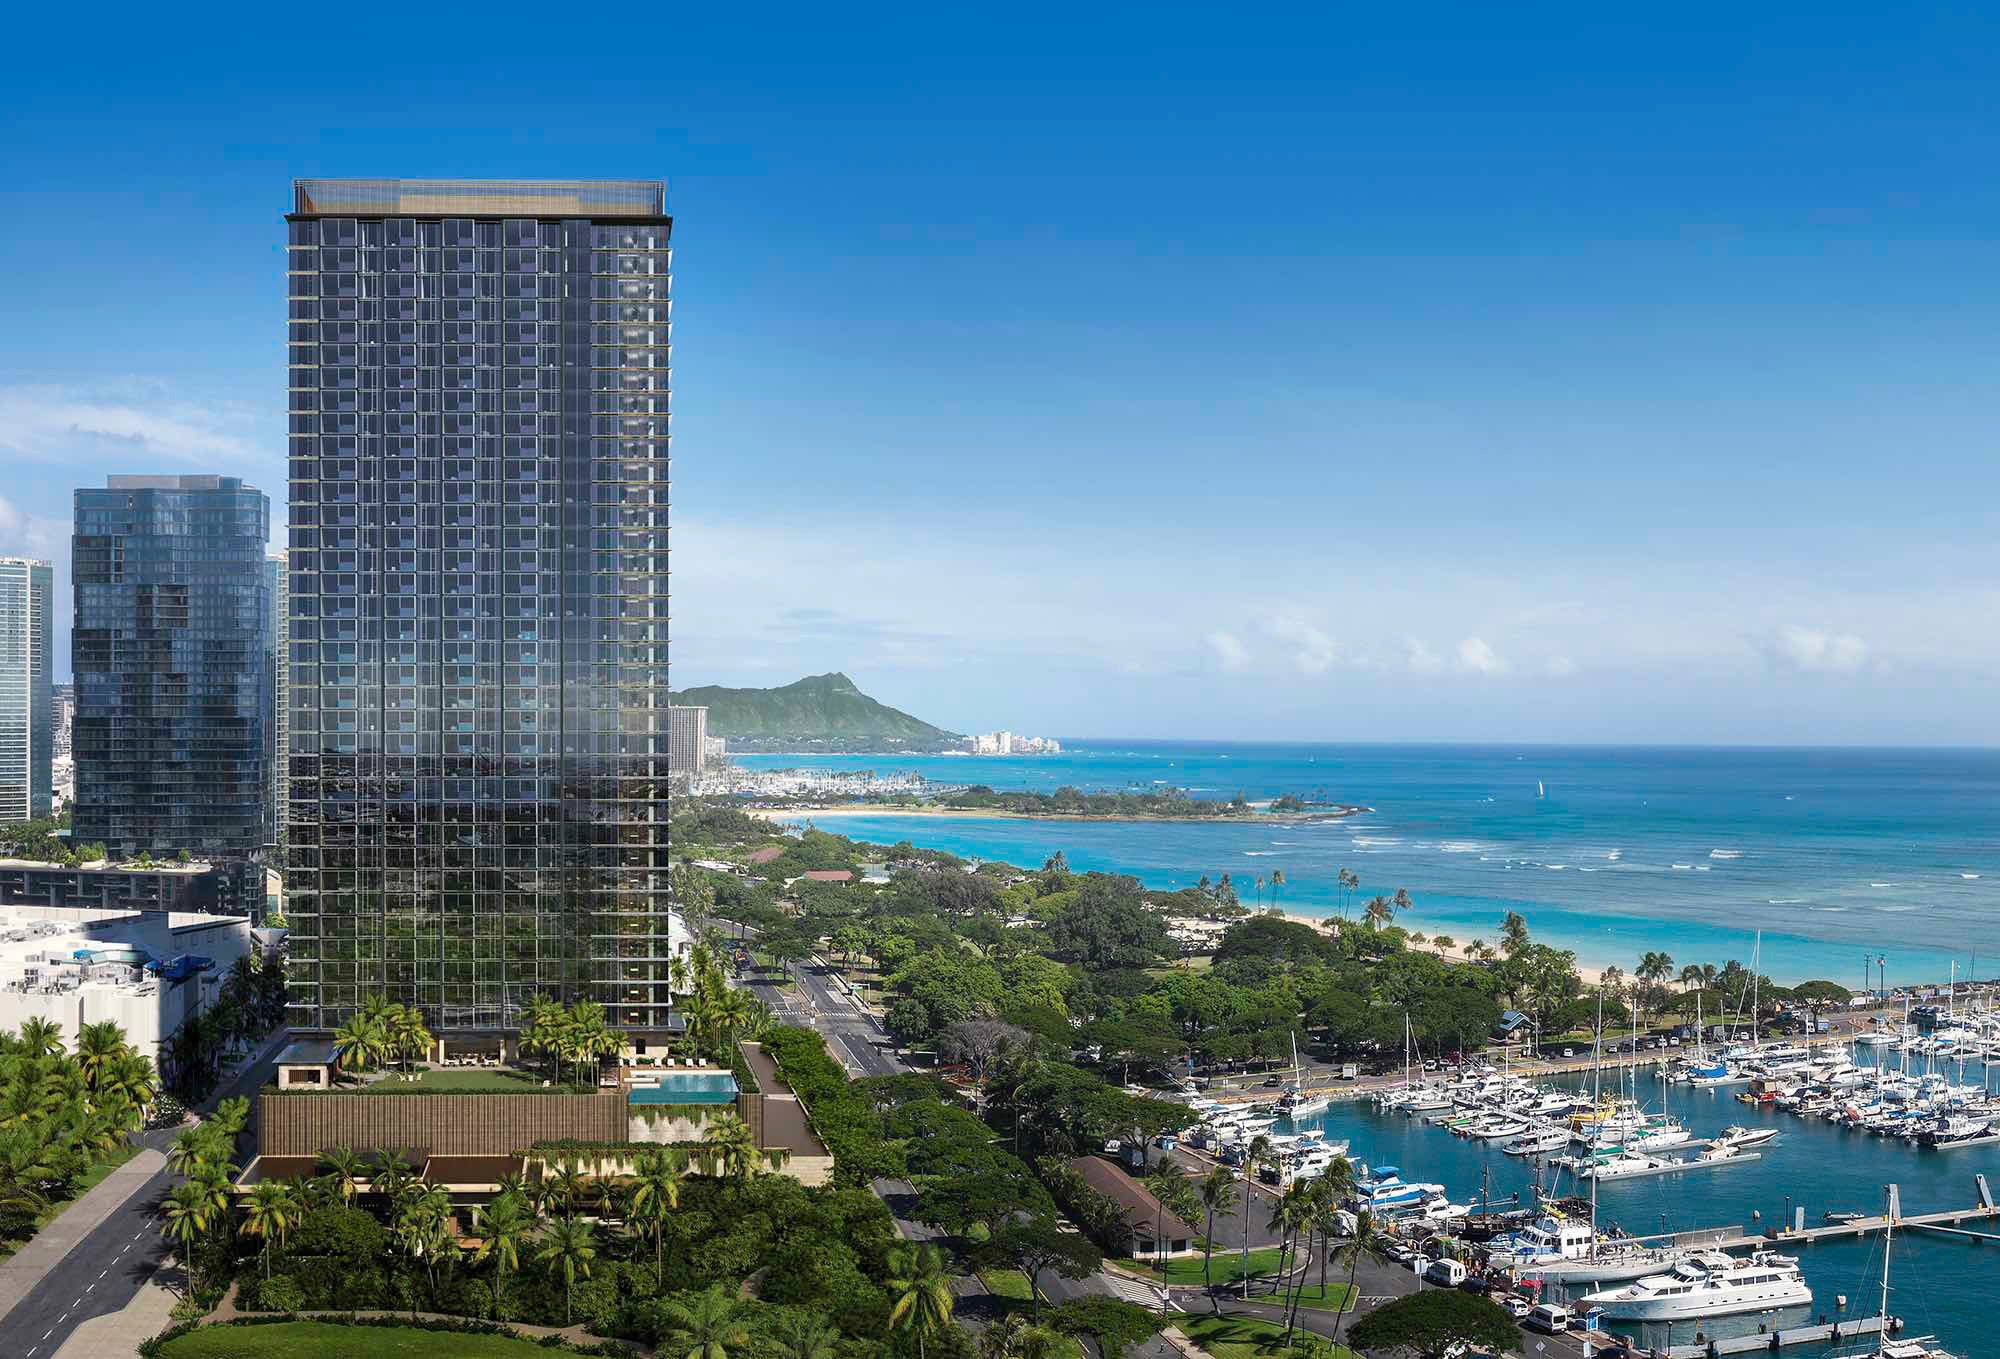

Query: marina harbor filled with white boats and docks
<box><xmin>1216</xmin><ymin>1015</ymin><xmax>2000</xmax><ymax>1359</ymax></box>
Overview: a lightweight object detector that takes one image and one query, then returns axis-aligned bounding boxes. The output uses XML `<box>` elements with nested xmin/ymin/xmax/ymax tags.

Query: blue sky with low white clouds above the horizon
<box><xmin>0</xmin><ymin>4</ymin><xmax>2000</xmax><ymax>743</ymax></box>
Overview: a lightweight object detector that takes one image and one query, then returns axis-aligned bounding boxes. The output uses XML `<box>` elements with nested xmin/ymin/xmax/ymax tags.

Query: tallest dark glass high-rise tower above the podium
<box><xmin>286</xmin><ymin>180</ymin><xmax>670</xmax><ymax>1031</ymax></box>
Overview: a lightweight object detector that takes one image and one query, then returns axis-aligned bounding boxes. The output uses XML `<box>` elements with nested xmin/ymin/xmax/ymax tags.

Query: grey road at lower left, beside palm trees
<box><xmin>0</xmin><ymin>1043</ymin><xmax>282</xmax><ymax>1359</ymax></box>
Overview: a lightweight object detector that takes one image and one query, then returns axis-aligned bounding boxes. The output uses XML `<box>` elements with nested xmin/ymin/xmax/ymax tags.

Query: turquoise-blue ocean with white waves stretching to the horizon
<box><xmin>734</xmin><ymin>739</ymin><xmax>2000</xmax><ymax>989</ymax></box>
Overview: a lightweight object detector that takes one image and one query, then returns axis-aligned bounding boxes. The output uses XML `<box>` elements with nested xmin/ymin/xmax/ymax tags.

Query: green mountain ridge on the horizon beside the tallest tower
<box><xmin>674</xmin><ymin>672</ymin><xmax>960</xmax><ymax>751</ymax></box>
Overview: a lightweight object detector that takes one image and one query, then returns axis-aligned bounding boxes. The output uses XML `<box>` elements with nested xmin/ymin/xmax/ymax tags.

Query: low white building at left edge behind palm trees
<box><xmin>0</xmin><ymin>905</ymin><xmax>262</xmax><ymax>1065</ymax></box>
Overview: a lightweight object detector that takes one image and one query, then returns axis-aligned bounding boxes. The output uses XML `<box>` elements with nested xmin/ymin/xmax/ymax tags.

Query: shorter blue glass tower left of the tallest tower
<box><xmin>70</xmin><ymin>476</ymin><xmax>272</xmax><ymax>871</ymax></box>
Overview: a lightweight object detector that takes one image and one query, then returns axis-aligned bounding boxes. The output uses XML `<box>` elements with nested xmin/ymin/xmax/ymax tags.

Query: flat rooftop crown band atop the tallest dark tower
<box><xmin>292</xmin><ymin>180</ymin><xmax>666</xmax><ymax>218</ymax></box>
